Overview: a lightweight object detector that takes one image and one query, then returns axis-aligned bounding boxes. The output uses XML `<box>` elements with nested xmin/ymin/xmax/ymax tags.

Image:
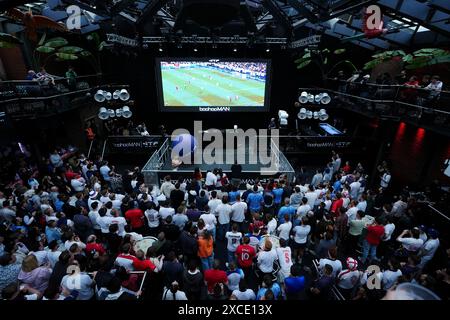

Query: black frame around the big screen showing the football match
<box><xmin>155</xmin><ymin>57</ymin><xmax>272</xmax><ymax>113</ymax></box>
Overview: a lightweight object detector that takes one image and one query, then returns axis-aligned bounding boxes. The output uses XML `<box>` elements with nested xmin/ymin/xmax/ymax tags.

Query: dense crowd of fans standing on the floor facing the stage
<box><xmin>0</xmin><ymin>140</ymin><xmax>450</xmax><ymax>300</ymax></box>
